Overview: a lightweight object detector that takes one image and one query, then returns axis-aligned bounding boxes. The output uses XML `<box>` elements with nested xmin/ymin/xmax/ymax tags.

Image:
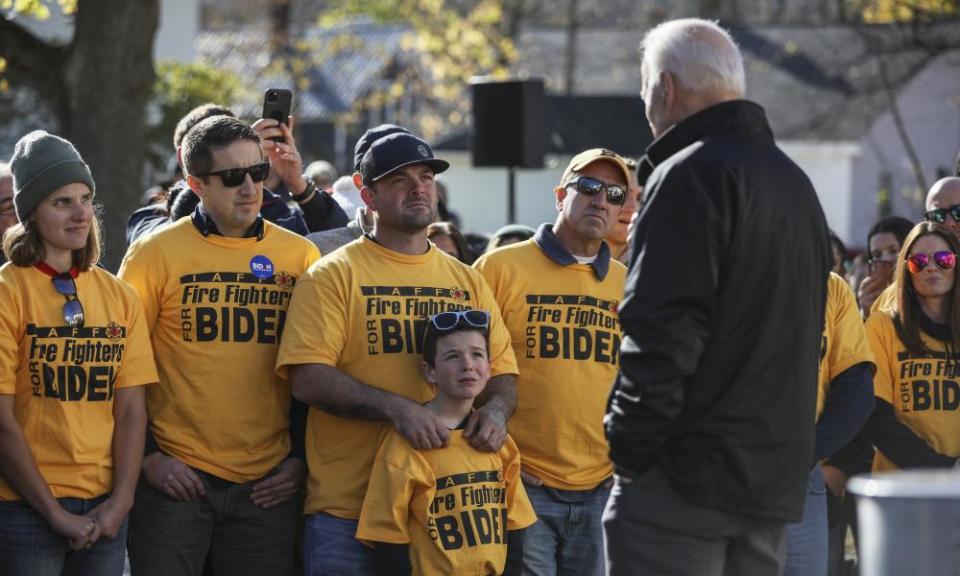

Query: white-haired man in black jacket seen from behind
<box><xmin>604</xmin><ymin>19</ymin><xmax>830</xmax><ymax>575</ymax></box>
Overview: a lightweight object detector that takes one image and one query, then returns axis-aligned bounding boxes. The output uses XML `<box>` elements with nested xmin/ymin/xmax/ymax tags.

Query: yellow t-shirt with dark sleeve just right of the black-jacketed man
<box><xmin>817</xmin><ymin>272</ymin><xmax>873</xmax><ymax>419</ymax></box>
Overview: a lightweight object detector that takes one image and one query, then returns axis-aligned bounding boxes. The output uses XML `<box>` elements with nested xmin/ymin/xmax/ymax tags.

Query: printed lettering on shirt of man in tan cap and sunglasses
<box><xmin>524</xmin><ymin>294</ymin><xmax>620</xmax><ymax>365</ymax></box>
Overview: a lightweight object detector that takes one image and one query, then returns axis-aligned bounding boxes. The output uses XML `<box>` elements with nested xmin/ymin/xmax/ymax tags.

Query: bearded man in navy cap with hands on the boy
<box><xmin>277</xmin><ymin>132</ymin><xmax>517</xmax><ymax>575</ymax></box>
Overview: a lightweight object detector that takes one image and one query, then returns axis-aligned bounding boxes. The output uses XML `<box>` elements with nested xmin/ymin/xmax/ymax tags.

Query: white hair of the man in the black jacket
<box><xmin>640</xmin><ymin>18</ymin><xmax>746</xmax><ymax>98</ymax></box>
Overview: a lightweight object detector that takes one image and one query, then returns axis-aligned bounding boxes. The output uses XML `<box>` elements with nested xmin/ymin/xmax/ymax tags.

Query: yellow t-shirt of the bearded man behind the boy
<box><xmin>277</xmin><ymin>237</ymin><xmax>517</xmax><ymax>519</ymax></box>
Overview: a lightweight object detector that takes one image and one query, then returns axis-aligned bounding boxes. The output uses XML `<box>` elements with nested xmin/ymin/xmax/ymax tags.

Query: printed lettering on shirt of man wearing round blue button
<box><xmin>180</xmin><ymin>272</ymin><xmax>296</xmax><ymax>345</ymax></box>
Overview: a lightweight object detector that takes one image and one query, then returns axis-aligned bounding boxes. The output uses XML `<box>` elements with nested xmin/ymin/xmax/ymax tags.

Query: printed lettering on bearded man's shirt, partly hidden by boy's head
<box><xmin>360</xmin><ymin>286</ymin><xmax>473</xmax><ymax>356</ymax></box>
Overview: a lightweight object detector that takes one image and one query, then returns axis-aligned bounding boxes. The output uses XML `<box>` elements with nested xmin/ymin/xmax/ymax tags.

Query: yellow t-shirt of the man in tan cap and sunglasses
<box><xmin>474</xmin><ymin>240</ymin><xmax>626</xmax><ymax>490</ymax></box>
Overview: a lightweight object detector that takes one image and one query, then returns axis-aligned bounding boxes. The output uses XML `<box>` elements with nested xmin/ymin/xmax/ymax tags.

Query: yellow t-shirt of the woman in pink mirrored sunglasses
<box><xmin>866</xmin><ymin>312</ymin><xmax>960</xmax><ymax>471</ymax></box>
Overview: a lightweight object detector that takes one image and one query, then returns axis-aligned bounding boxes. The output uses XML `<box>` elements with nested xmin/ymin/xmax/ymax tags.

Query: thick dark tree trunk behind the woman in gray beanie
<box><xmin>61</xmin><ymin>0</ymin><xmax>159</xmax><ymax>271</ymax></box>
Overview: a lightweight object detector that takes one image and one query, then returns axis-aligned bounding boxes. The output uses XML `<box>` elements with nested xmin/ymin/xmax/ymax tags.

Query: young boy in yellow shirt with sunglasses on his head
<box><xmin>357</xmin><ymin>310</ymin><xmax>536</xmax><ymax>574</ymax></box>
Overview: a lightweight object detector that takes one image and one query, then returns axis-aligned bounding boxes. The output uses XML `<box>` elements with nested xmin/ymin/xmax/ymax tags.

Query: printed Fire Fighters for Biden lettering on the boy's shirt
<box><xmin>427</xmin><ymin>470</ymin><xmax>507</xmax><ymax>550</ymax></box>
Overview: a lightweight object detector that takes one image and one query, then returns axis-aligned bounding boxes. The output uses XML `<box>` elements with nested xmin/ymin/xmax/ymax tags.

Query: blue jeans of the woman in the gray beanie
<box><xmin>0</xmin><ymin>495</ymin><xmax>127</xmax><ymax>576</ymax></box>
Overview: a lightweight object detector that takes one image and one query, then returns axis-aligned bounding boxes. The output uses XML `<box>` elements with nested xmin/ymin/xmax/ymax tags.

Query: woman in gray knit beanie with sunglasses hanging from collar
<box><xmin>0</xmin><ymin>131</ymin><xmax>157</xmax><ymax>576</ymax></box>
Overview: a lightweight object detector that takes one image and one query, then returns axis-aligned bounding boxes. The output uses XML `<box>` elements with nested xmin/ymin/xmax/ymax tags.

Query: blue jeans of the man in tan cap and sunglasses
<box><xmin>523</xmin><ymin>485</ymin><xmax>610</xmax><ymax>576</ymax></box>
